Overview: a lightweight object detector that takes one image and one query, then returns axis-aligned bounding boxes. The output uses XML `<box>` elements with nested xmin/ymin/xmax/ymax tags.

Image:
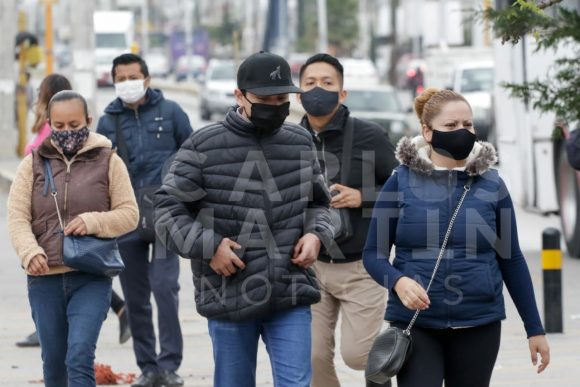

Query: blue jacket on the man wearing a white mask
<box><xmin>97</xmin><ymin>88</ymin><xmax>192</xmax><ymax>189</ymax></box>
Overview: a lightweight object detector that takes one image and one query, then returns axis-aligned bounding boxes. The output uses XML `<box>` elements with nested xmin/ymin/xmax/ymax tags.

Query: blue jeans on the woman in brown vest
<box><xmin>28</xmin><ymin>272</ymin><xmax>112</xmax><ymax>387</ymax></box>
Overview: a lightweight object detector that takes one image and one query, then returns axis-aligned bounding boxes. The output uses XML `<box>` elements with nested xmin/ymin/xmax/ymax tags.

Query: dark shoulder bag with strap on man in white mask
<box><xmin>115</xmin><ymin>114</ymin><xmax>159</xmax><ymax>243</ymax></box>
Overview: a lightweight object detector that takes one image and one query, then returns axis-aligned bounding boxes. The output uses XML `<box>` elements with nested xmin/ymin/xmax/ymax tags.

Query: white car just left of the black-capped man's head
<box><xmin>199</xmin><ymin>59</ymin><xmax>237</xmax><ymax>121</ymax></box>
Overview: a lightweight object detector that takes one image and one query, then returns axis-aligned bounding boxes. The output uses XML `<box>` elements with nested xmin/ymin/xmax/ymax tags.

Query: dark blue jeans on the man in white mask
<box><xmin>119</xmin><ymin>232</ymin><xmax>183</xmax><ymax>372</ymax></box>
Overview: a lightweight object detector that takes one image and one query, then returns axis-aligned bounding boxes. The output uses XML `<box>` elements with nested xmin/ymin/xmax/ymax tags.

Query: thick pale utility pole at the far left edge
<box><xmin>0</xmin><ymin>0</ymin><xmax>18</xmax><ymax>158</ymax></box>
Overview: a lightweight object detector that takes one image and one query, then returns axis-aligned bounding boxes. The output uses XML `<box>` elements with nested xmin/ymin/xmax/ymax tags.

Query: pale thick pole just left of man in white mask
<box><xmin>69</xmin><ymin>1</ymin><xmax>95</xmax><ymax>119</ymax></box>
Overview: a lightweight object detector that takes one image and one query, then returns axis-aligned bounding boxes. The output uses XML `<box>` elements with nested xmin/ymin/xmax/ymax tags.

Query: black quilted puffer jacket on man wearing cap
<box><xmin>156</xmin><ymin>110</ymin><xmax>332</xmax><ymax>321</ymax></box>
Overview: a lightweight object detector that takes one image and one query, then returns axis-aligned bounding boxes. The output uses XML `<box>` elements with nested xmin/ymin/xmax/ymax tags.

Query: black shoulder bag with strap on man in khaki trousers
<box><xmin>324</xmin><ymin>117</ymin><xmax>354</xmax><ymax>243</ymax></box>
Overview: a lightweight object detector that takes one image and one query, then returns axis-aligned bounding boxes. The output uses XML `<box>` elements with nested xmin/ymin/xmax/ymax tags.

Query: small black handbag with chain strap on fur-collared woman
<box><xmin>365</xmin><ymin>178</ymin><xmax>473</xmax><ymax>384</ymax></box>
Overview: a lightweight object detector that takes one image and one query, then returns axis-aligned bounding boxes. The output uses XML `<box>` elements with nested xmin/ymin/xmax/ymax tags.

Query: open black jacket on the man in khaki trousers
<box><xmin>301</xmin><ymin>106</ymin><xmax>398</xmax><ymax>263</ymax></box>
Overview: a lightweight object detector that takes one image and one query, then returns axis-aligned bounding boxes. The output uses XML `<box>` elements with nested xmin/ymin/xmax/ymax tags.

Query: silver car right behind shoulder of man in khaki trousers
<box><xmin>344</xmin><ymin>85</ymin><xmax>414</xmax><ymax>145</ymax></box>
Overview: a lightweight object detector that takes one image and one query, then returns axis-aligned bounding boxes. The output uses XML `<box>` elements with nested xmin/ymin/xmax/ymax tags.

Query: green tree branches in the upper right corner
<box><xmin>480</xmin><ymin>0</ymin><xmax>580</xmax><ymax>129</ymax></box>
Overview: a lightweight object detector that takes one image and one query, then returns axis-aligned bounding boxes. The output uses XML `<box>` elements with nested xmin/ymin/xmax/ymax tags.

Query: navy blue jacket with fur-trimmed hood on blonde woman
<box><xmin>363</xmin><ymin>137</ymin><xmax>543</xmax><ymax>336</ymax></box>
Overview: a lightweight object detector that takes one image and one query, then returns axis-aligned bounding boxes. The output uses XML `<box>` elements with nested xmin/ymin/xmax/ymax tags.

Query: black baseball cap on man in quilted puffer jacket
<box><xmin>238</xmin><ymin>51</ymin><xmax>302</xmax><ymax>97</ymax></box>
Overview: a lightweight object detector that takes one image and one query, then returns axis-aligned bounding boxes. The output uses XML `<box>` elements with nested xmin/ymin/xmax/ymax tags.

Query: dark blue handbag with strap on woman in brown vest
<box><xmin>44</xmin><ymin>159</ymin><xmax>125</xmax><ymax>277</ymax></box>
